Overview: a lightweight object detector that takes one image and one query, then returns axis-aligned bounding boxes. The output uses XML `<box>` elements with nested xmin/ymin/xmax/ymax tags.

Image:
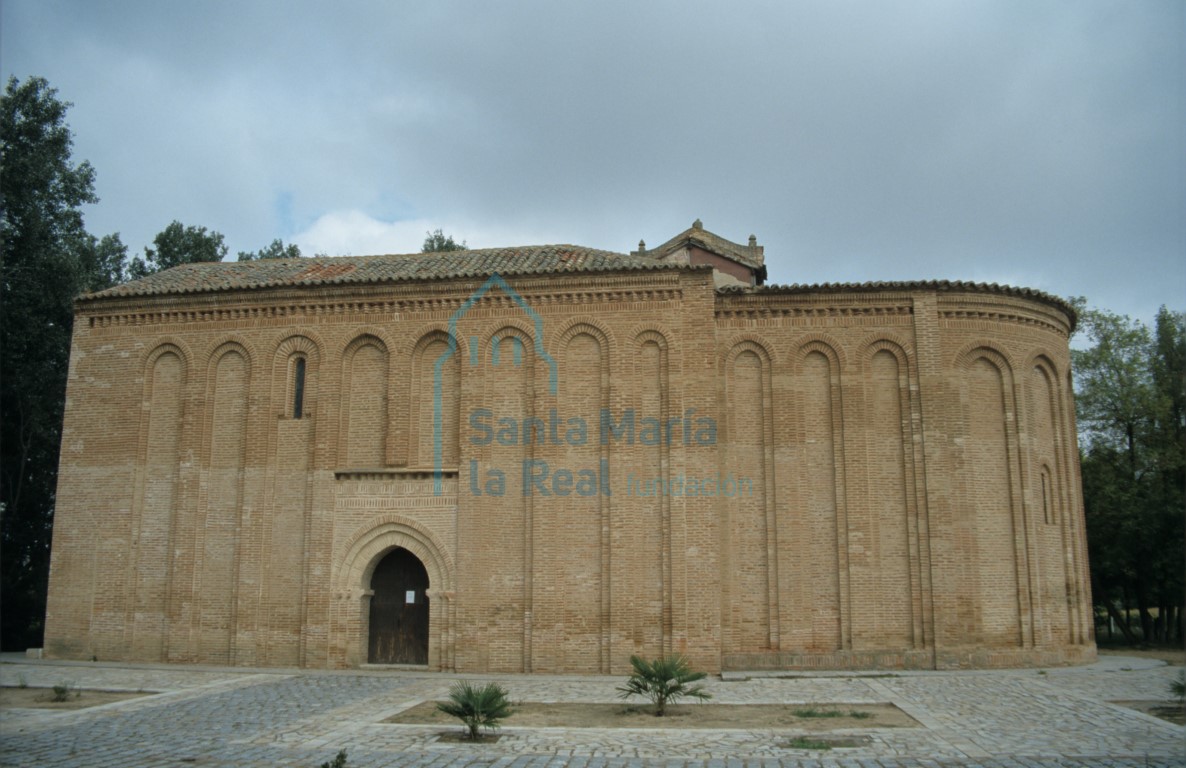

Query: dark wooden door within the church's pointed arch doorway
<box><xmin>366</xmin><ymin>546</ymin><xmax>428</xmax><ymax>664</ymax></box>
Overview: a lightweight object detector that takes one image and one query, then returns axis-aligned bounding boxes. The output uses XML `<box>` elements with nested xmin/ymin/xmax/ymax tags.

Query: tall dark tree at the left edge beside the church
<box><xmin>0</xmin><ymin>77</ymin><xmax>123</xmax><ymax>648</ymax></box>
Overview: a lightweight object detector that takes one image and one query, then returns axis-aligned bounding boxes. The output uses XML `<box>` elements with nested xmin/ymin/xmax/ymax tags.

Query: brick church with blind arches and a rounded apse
<box><xmin>45</xmin><ymin>222</ymin><xmax>1095</xmax><ymax>674</ymax></box>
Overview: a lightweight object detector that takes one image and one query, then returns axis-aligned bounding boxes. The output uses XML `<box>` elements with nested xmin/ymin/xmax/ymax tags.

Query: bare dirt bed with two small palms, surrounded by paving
<box><xmin>384</xmin><ymin>702</ymin><xmax>918</xmax><ymax>732</ymax></box>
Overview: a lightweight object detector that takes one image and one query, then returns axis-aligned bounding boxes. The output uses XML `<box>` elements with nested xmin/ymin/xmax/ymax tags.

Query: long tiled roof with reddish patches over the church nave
<box><xmin>81</xmin><ymin>245</ymin><xmax>687</xmax><ymax>301</ymax></box>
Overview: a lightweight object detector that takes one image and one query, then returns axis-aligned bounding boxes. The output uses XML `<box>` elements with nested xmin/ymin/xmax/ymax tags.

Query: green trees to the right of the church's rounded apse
<box><xmin>1071</xmin><ymin>300</ymin><xmax>1186</xmax><ymax>644</ymax></box>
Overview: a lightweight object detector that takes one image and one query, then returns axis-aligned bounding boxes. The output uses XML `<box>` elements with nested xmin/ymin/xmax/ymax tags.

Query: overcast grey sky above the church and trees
<box><xmin>0</xmin><ymin>0</ymin><xmax>1186</xmax><ymax>321</ymax></box>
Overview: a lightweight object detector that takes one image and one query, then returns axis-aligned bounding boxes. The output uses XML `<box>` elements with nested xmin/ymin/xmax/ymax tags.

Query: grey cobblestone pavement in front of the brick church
<box><xmin>0</xmin><ymin>655</ymin><xmax>1186</xmax><ymax>768</ymax></box>
